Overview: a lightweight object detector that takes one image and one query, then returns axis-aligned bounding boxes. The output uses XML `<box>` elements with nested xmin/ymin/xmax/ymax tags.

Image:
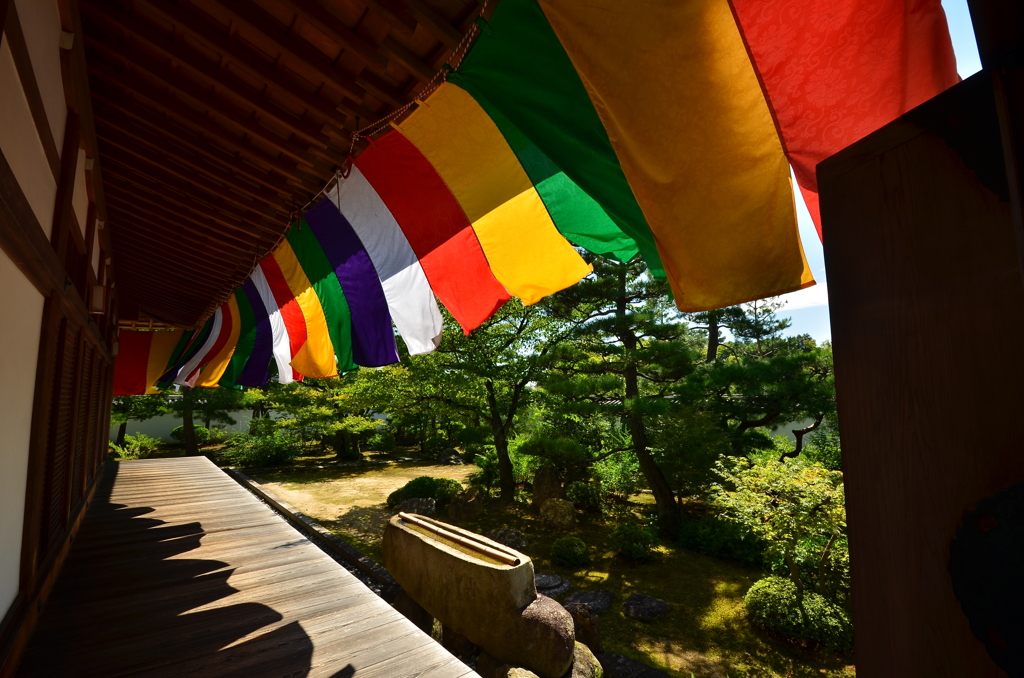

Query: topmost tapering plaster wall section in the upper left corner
<box><xmin>14</xmin><ymin>0</ymin><xmax>68</xmax><ymax>153</ymax></box>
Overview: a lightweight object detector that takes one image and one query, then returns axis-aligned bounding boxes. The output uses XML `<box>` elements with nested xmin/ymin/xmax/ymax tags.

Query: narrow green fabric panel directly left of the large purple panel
<box><xmin>286</xmin><ymin>219</ymin><xmax>358</xmax><ymax>374</ymax></box>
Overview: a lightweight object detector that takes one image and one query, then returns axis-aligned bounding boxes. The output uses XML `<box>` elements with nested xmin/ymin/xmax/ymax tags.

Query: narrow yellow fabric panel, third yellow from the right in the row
<box><xmin>273</xmin><ymin>240</ymin><xmax>338</xmax><ymax>379</ymax></box>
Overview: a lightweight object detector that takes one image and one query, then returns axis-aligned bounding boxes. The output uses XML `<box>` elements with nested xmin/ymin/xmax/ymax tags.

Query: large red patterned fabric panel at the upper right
<box><xmin>731</xmin><ymin>0</ymin><xmax>959</xmax><ymax>237</ymax></box>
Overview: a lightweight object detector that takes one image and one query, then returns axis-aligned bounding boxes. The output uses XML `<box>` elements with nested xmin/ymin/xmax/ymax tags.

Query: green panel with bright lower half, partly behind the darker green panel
<box><xmin>468</xmin><ymin>94</ymin><xmax>638</xmax><ymax>262</ymax></box>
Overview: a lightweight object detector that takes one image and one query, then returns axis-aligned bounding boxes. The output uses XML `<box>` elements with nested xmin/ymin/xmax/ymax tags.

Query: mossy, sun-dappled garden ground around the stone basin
<box><xmin>252</xmin><ymin>453</ymin><xmax>855</xmax><ymax>678</ymax></box>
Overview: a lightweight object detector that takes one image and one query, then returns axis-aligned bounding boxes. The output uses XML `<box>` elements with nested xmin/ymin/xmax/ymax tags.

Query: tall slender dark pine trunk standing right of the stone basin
<box><xmin>615</xmin><ymin>264</ymin><xmax>682</xmax><ymax>539</ymax></box>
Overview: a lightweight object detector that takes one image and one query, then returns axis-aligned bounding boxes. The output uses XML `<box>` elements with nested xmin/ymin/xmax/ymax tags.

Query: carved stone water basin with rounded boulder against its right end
<box><xmin>384</xmin><ymin>516</ymin><xmax>574</xmax><ymax>678</ymax></box>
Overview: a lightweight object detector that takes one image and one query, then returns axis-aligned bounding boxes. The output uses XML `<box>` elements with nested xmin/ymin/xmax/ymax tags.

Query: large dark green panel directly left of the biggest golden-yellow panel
<box><xmin>449</xmin><ymin>0</ymin><xmax>665</xmax><ymax>278</ymax></box>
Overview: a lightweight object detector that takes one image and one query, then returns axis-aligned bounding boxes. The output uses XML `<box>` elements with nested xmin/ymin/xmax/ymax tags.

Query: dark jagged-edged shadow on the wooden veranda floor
<box><xmin>17</xmin><ymin>464</ymin><xmax>313</xmax><ymax>678</ymax></box>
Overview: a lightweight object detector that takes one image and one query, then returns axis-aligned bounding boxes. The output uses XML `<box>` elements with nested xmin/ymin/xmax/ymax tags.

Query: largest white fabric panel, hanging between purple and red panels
<box><xmin>328</xmin><ymin>166</ymin><xmax>442</xmax><ymax>355</ymax></box>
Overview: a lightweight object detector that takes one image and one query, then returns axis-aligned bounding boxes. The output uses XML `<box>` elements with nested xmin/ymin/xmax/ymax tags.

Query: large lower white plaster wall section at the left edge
<box><xmin>0</xmin><ymin>248</ymin><xmax>43</xmax><ymax>617</ymax></box>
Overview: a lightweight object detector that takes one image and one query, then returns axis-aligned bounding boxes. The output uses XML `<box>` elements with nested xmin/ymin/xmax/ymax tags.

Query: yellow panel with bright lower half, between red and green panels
<box><xmin>398</xmin><ymin>83</ymin><xmax>591</xmax><ymax>304</ymax></box>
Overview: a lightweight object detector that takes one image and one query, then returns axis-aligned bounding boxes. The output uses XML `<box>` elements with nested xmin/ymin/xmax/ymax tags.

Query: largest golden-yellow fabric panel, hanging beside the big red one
<box><xmin>540</xmin><ymin>0</ymin><xmax>814</xmax><ymax>311</ymax></box>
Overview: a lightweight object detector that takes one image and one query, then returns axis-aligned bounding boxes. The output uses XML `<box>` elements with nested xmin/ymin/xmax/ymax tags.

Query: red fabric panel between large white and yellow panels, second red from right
<box><xmin>355</xmin><ymin>131</ymin><xmax>510</xmax><ymax>334</ymax></box>
